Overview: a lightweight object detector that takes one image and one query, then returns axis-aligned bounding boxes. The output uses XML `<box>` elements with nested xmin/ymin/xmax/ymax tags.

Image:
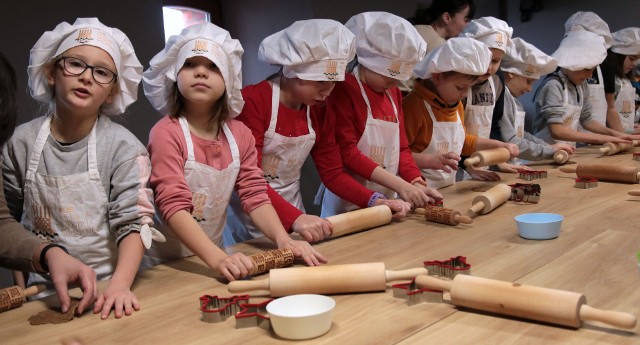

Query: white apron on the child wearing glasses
<box><xmin>21</xmin><ymin>116</ymin><xmax>118</xmax><ymax>290</ymax></box>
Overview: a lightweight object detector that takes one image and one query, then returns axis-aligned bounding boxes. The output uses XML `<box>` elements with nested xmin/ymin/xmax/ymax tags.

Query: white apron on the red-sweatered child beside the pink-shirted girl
<box><xmin>224</xmin><ymin>79</ymin><xmax>316</xmax><ymax>246</ymax></box>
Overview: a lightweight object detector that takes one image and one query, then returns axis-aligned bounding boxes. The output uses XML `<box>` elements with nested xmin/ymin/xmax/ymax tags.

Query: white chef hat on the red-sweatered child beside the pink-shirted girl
<box><xmin>258</xmin><ymin>19</ymin><xmax>356</xmax><ymax>81</ymax></box>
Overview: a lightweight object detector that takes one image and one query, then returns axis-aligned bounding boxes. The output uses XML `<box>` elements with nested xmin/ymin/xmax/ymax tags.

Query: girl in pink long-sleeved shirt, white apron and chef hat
<box><xmin>143</xmin><ymin>23</ymin><xmax>326</xmax><ymax>280</ymax></box>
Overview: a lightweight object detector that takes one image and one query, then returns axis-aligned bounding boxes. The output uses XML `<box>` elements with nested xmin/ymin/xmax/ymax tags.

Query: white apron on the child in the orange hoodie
<box><xmin>421</xmin><ymin>101</ymin><xmax>465</xmax><ymax>189</ymax></box>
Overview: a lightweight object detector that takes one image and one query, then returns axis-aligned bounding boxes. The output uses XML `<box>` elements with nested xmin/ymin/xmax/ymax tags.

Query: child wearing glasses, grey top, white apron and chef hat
<box><xmin>2</xmin><ymin>18</ymin><xmax>161</xmax><ymax>319</ymax></box>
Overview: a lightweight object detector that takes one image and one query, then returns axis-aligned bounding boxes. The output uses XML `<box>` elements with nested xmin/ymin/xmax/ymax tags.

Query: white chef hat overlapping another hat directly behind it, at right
<box><xmin>551</xmin><ymin>30</ymin><xmax>607</xmax><ymax>71</ymax></box>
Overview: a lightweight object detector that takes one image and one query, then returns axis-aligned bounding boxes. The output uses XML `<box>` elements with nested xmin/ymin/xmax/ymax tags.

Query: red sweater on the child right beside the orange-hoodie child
<box><xmin>327</xmin><ymin>73</ymin><xmax>422</xmax><ymax>182</ymax></box>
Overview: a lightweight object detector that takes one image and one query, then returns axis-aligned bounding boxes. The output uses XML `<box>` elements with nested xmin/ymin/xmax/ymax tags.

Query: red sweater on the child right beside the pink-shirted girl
<box><xmin>237</xmin><ymin>80</ymin><xmax>373</xmax><ymax>230</ymax></box>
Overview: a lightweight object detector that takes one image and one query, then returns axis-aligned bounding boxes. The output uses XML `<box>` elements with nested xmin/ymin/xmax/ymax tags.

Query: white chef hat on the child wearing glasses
<box><xmin>27</xmin><ymin>18</ymin><xmax>142</xmax><ymax>115</ymax></box>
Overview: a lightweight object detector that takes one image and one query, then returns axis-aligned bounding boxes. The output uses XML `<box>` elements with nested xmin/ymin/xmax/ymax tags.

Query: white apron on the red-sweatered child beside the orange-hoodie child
<box><xmin>321</xmin><ymin>67</ymin><xmax>400</xmax><ymax>218</ymax></box>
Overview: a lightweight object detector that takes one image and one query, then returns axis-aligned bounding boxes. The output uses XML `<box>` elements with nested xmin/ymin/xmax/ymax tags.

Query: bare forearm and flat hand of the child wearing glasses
<box><xmin>93</xmin><ymin>232</ymin><xmax>144</xmax><ymax>320</ymax></box>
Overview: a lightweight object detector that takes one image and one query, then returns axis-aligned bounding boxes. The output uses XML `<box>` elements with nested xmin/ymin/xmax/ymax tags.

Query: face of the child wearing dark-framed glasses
<box><xmin>47</xmin><ymin>45</ymin><xmax>117</xmax><ymax>114</ymax></box>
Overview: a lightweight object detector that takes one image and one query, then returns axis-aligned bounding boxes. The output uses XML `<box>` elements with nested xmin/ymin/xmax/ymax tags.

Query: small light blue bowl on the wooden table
<box><xmin>515</xmin><ymin>213</ymin><xmax>564</xmax><ymax>240</ymax></box>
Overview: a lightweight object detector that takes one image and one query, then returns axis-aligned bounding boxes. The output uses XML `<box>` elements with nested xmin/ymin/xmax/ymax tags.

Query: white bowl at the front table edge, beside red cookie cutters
<box><xmin>267</xmin><ymin>295</ymin><xmax>336</xmax><ymax>339</ymax></box>
